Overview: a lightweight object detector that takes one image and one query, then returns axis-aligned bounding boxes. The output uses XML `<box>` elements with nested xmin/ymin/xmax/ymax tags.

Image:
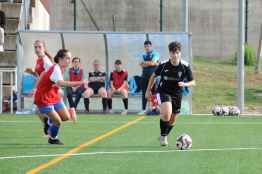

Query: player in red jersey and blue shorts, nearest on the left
<box><xmin>35</xmin><ymin>49</ymin><xmax>85</xmax><ymax>144</ymax></box>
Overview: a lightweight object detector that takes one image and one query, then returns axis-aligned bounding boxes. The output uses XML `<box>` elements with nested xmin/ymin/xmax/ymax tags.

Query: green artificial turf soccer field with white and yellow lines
<box><xmin>0</xmin><ymin>115</ymin><xmax>262</xmax><ymax>174</ymax></box>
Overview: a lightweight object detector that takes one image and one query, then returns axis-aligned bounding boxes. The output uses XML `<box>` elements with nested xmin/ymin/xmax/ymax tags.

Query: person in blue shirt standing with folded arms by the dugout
<box><xmin>138</xmin><ymin>40</ymin><xmax>159</xmax><ymax>115</ymax></box>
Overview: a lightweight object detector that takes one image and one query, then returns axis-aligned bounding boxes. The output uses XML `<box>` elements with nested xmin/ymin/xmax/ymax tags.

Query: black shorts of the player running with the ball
<box><xmin>157</xmin><ymin>92</ymin><xmax>182</xmax><ymax>114</ymax></box>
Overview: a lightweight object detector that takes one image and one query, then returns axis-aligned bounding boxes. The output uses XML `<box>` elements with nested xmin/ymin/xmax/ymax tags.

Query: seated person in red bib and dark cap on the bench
<box><xmin>107</xmin><ymin>60</ymin><xmax>128</xmax><ymax>115</ymax></box>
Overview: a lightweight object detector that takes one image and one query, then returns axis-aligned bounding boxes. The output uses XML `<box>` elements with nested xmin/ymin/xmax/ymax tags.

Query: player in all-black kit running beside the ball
<box><xmin>146</xmin><ymin>42</ymin><xmax>195</xmax><ymax>146</ymax></box>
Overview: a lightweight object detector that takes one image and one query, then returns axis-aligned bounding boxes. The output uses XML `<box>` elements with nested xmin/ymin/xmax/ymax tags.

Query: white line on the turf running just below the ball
<box><xmin>0</xmin><ymin>147</ymin><xmax>262</xmax><ymax>160</ymax></box>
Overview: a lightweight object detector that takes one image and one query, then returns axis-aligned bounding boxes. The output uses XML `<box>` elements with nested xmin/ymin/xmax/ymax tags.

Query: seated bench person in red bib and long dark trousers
<box><xmin>66</xmin><ymin>57</ymin><xmax>86</xmax><ymax>109</ymax></box>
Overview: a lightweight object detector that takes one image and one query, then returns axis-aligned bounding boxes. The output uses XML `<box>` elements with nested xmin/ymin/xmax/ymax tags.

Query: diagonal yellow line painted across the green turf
<box><xmin>26</xmin><ymin>116</ymin><xmax>145</xmax><ymax>174</ymax></box>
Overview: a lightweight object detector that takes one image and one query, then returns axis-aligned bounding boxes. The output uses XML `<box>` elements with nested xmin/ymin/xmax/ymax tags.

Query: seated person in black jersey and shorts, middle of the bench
<box><xmin>84</xmin><ymin>59</ymin><xmax>107</xmax><ymax>112</ymax></box>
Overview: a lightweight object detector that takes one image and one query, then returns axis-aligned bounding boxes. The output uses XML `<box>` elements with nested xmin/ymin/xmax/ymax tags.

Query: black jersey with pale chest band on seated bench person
<box><xmin>88</xmin><ymin>71</ymin><xmax>106</xmax><ymax>88</ymax></box>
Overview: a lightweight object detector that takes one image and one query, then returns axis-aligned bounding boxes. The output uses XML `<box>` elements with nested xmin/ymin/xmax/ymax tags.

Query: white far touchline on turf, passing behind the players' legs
<box><xmin>0</xmin><ymin>120</ymin><xmax>262</xmax><ymax>126</ymax></box>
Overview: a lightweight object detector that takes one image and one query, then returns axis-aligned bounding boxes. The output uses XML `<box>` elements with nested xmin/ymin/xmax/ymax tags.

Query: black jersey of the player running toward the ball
<box><xmin>155</xmin><ymin>60</ymin><xmax>194</xmax><ymax>95</ymax></box>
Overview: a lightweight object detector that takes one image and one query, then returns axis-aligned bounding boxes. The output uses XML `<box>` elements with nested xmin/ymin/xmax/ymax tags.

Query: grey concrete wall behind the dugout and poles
<box><xmin>50</xmin><ymin>0</ymin><xmax>262</xmax><ymax>58</ymax></box>
